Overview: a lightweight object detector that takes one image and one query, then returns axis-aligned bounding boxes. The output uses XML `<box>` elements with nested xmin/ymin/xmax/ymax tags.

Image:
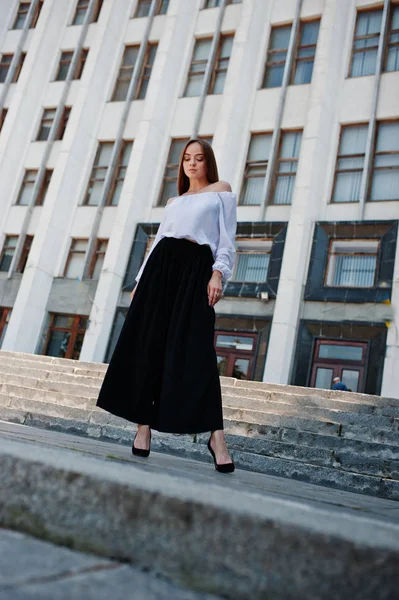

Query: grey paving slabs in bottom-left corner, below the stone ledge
<box><xmin>0</xmin><ymin>529</ymin><xmax>217</xmax><ymax>600</ymax></box>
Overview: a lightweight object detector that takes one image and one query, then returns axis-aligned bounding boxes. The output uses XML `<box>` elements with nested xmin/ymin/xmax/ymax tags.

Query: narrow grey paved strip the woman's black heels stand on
<box><xmin>0</xmin><ymin>421</ymin><xmax>399</xmax><ymax>524</ymax></box>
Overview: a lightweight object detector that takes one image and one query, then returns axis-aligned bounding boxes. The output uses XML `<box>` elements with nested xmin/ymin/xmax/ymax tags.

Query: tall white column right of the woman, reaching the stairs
<box><xmin>263</xmin><ymin>0</ymin><xmax>352</xmax><ymax>383</ymax></box>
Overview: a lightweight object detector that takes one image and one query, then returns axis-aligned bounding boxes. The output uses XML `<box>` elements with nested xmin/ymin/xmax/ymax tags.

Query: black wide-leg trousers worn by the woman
<box><xmin>97</xmin><ymin>237</ymin><xmax>223</xmax><ymax>433</ymax></box>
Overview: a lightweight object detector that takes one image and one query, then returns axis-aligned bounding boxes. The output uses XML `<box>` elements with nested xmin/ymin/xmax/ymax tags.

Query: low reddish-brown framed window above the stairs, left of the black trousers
<box><xmin>43</xmin><ymin>313</ymin><xmax>88</xmax><ymax>360</ymax></box>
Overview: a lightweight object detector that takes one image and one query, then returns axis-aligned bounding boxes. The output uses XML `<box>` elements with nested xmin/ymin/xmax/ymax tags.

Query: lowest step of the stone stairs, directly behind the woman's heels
<box><xmin>0</xmin><ymin>407</ymin><xmax>399</xmax><ymax>500</ymax></box>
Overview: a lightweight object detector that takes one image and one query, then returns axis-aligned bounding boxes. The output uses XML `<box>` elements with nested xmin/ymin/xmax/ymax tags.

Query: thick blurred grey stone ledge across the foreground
<box><xmin>0</xmin><ymin>439</ymin><xmax>399</xmax><ymax>600</ymax></box>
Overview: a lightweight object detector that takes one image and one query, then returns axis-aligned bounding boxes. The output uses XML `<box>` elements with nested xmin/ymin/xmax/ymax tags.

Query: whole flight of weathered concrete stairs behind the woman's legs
<box><xmin>0</xmin><ymin>351</ymin><xmax>399</xmax><ymax>500</ymax></box>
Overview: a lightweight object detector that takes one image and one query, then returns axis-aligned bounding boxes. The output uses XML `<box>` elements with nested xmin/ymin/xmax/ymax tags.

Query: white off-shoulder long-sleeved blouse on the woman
<box><xmin>136</xmin><ymin>192</ymin><xmax>237</xmax><ymax>282</ymax></box>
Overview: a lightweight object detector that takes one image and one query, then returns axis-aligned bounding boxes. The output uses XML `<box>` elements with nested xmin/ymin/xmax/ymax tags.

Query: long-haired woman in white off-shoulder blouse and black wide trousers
<box><xmin>97</xmin><ymin>138</ymin><xmax>237</xmax><ymax>473</ymax></box>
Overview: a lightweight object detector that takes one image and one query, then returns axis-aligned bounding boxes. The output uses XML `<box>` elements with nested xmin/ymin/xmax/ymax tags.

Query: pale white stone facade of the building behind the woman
<box><xmin>0</xmin><ymin>0</ymin><xmax>399</xmax><ymax>397</ymax></box>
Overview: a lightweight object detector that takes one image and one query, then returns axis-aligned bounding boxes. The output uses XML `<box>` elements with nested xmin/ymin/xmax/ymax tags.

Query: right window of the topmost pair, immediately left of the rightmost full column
<box><xmin>292</xmin><ymin>21</ymin><xmax>320</xmax><ymax>85</ymax></box>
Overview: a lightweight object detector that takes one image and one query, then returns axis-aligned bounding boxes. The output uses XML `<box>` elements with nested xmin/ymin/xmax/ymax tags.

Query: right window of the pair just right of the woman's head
<box><xmin>273</xmin><ymin>131</ymin><xmax>302</xmax><ymax>204</ymax></box>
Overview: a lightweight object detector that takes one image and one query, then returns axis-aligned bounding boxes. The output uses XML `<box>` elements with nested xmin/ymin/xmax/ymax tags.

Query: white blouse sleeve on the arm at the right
<box><xmin>212</xmin><ymin>193</ymin><xmax>237</xmax><ymax>283</ymax></box>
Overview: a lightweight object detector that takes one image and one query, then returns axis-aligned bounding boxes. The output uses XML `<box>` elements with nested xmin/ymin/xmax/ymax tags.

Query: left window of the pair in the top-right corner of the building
<box><xmin>350</xmin><ymin>8</ymin><xmax>382</xmax><ymax>77</ymax></box>
